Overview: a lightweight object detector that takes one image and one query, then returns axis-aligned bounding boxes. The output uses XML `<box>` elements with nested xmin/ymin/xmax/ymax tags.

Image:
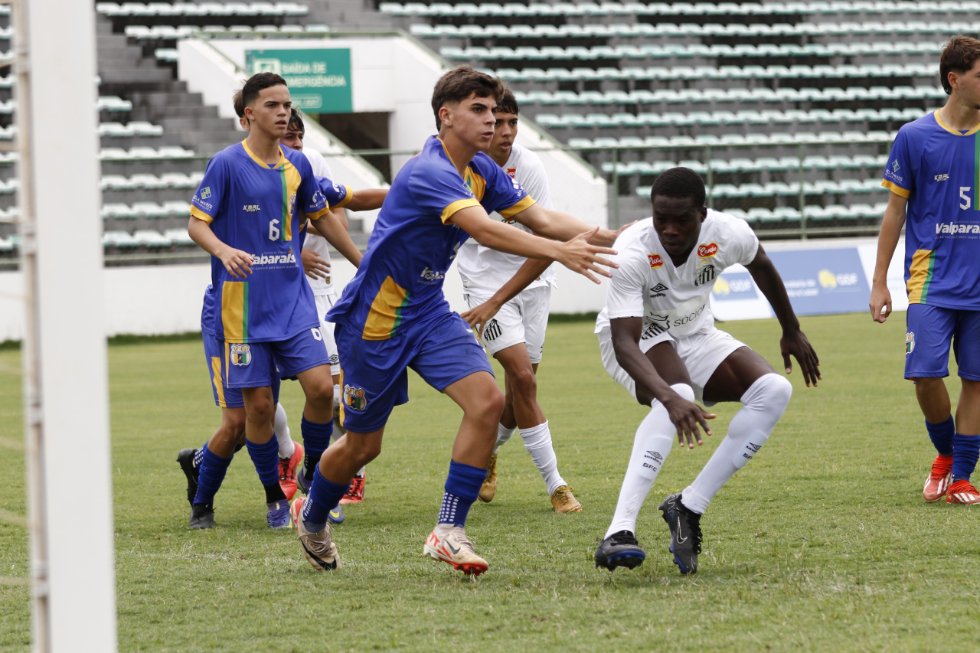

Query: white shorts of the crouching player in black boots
<box><xmin>596</xmin><ymin>326</ymin><xmax>746</xmax><ymax>401</ymax></box>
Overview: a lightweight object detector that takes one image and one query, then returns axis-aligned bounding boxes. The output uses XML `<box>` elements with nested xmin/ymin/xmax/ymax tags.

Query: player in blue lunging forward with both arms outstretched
<box><xmin>293</xmin><ymin>66</ymin><xmax>612</xmax><ymax>574</ymax></box>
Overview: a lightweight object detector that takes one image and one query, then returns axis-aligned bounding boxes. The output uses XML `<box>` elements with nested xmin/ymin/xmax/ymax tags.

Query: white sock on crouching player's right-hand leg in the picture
<box><xmin>681</xmin><ymin>372</ymin><xmax>793</xmax><ymax>514</ymax></box>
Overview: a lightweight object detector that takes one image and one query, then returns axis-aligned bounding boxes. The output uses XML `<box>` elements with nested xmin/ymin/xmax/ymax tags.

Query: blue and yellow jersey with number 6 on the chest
<box><xmin>191</xmin><ymin>141</ymin><xmax>329</xmax><ymax>343</ymax></box>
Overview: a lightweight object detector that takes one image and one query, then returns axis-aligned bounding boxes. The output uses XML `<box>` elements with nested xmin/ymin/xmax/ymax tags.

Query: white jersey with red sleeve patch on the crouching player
<box><xmin>596</xmin><ymin>209</ymin><xmax>759</xmax><ymax>338</ymax></box>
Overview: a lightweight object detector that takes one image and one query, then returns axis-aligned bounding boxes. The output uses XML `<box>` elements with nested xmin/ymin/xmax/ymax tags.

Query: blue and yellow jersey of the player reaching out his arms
<box><xmin>327</xmin><ymin>136</ymin><xmax>534</xmax><ymax>340</ymax></box>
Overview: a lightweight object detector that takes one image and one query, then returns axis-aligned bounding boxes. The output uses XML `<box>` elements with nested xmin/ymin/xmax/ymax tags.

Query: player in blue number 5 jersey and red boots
<box><xmin>869</xmin><ymin>36</ymin><xmax>980</xmax><ymax>504</ymax></box>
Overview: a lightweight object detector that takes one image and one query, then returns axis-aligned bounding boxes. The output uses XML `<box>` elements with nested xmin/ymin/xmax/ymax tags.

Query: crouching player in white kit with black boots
<box><xmin>595</xmin><ymin>168</ymin><xmax>820</xmax><ymax>574</ymax></box>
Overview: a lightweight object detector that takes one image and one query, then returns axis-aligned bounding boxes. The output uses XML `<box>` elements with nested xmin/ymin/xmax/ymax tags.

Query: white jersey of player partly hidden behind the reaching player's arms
<box><xmin>456</xmin><ymin>143</ymin><xmax>555</xmax><ymax>297</ymax></box>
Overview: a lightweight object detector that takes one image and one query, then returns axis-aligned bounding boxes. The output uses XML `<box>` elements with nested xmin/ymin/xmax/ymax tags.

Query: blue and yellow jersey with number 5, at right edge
<box><xmin>881</xmin><ymin>111</ymin><xmax>980</xmax><ymax>310</ymax></box>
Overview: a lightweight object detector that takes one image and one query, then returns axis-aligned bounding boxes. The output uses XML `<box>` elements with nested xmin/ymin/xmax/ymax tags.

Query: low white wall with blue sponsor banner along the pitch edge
<box><xmin>0</xmin><ymin>239</ymin><xmax>907</xmax><ymax>342</ymax></box>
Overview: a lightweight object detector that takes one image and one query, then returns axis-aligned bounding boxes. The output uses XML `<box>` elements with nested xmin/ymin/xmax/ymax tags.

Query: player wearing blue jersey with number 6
<box><xmin>188</xmin><ymin>73</ymin><xmax>352</xmax><ymax>527</ymax></box>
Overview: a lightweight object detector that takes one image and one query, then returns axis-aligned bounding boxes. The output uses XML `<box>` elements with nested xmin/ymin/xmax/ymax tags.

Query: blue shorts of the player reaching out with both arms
<box><xmin>334</xmin><ymin>313</ymin><xmax>493</xmax><ymax>433</ymax></box>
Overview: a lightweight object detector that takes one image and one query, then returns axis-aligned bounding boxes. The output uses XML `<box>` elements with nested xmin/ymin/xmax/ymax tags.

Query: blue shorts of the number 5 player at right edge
<box><xmin>905</xmin><ymin>304</ymin><xmax>980</xmax><ymax>381</ymax></box>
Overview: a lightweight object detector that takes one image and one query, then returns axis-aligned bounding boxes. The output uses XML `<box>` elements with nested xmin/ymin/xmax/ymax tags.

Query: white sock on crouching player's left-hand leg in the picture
<box><xmin>603</xmin><ymin>383</ymin><xmax>694</xmax><ymax>539</ymax></box>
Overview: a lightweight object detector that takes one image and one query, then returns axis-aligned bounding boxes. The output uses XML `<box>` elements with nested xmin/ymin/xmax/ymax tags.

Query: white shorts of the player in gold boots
<box><xmin>463</xmin><ymin>286</ymin><xmax>551</xmax><ymax>363</ymax></box>
